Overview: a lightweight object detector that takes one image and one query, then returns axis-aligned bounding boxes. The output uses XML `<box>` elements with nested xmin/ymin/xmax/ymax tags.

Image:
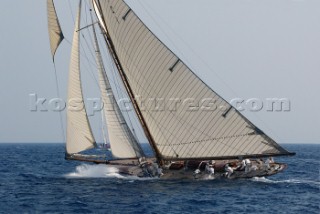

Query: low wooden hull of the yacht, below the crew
<box><xmin>107</xmin><ymin>159</ymin><xmax>287</xmax><ymax>180</ymax></box>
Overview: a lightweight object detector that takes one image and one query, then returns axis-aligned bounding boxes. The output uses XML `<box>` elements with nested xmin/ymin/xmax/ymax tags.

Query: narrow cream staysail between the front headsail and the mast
<box><xmin>92</xmin><ymin>12</ymin><xmax>144</xmax><ymax>158</ymax></box>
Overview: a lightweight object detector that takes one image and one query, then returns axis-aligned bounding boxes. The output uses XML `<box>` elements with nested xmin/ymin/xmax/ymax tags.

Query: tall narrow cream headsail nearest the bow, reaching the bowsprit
<box><xmin>66</xmin><ymin>0</ymin><xmax>96</xmax><ymax>154</ymax></box>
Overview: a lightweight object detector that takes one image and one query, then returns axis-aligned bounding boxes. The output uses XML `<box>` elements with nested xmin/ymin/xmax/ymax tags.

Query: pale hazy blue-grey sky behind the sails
<box><xmin>0</xmin><ymin>0</ymin><xmax>320</xmax><ymax>143</ymax></box>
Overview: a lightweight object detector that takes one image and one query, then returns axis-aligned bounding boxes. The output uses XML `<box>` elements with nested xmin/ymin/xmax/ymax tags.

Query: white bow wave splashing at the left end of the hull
<box><xmin>64</xmin><ymin>164</ymin><xmax>158</xmax><ymax>180</ymax></box>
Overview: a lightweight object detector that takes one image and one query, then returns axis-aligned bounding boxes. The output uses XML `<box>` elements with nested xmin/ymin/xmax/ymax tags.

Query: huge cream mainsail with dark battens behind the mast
<box><xmin>94</xmin><ymin>0</ymin><xmax>290</xmax><ymax>160</ymax></box>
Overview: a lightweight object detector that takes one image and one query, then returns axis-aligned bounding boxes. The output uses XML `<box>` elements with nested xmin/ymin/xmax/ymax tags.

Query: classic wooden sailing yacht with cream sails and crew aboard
<box><xmin>47</xmin><ymin>0</ymin><xmax>294</xmax><ymax>179</ymax></box>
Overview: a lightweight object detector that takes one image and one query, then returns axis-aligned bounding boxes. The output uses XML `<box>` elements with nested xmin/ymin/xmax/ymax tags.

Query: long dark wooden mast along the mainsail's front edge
<box><xmin>93</xmin><ymin>0</ymin><xmax>162</xmax><ymax>164</ymax></box>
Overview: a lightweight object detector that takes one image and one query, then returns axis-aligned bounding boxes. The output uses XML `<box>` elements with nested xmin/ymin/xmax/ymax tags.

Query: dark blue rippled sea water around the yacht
<box><xmin>0</xmin><ymin>144</ymin><xmax>320</xmax><ymax>214</ymax></box>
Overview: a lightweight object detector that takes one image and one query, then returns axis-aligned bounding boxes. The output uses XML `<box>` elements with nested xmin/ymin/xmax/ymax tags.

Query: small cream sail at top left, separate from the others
<box><xmin>47</xmin><ymin>0</ymin><xmax>64</xmax><ymax>59</ymax></box>
